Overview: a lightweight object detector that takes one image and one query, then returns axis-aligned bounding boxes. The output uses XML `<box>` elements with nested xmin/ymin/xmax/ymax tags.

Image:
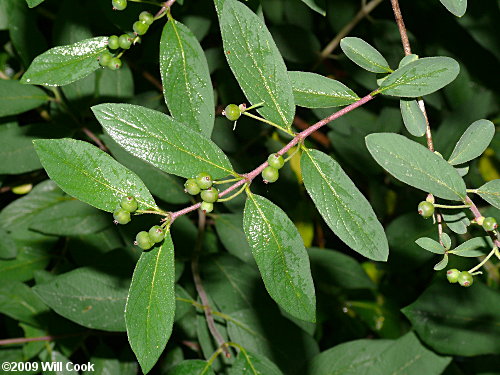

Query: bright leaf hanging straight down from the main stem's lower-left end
<box><xmin>125</xmin><ymin>233</ymin><xmax>175</xmax><ymax>374</ymax></box>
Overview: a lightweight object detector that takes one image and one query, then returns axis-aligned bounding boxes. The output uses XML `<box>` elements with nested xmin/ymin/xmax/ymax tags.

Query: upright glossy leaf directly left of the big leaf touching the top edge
<box><xmin>160</xmin><ymin>18</ymin><xmax>215</xmax><ymax>138</ymax></box>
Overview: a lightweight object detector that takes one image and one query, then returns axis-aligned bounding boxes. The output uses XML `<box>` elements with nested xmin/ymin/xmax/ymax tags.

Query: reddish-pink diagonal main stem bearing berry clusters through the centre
<box><xmin>170</xmin><ymin>93</ymin><xmax>374</xmax><ymax>222</ymax></box>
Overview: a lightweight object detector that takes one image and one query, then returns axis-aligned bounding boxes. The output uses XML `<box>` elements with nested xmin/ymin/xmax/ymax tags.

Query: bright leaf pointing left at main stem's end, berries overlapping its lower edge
<box><xmin>34</xmin><ymin>139</ymin><xmax>156</xmax><ymax>212</ymax></box>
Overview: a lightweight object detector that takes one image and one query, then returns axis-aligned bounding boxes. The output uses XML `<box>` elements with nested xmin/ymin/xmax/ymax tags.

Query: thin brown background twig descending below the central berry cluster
<box><xmin>191</xmin><ymin>210</ymin><xmax>231</xmax><ymax>358</ymax></box>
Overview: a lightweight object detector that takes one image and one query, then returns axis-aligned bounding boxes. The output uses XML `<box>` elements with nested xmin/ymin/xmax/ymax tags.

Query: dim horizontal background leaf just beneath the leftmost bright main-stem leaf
<box><xmin>30</xmin><ymin>201</ymin><xmax>109</xmax><ymax>236</ymax></box>
